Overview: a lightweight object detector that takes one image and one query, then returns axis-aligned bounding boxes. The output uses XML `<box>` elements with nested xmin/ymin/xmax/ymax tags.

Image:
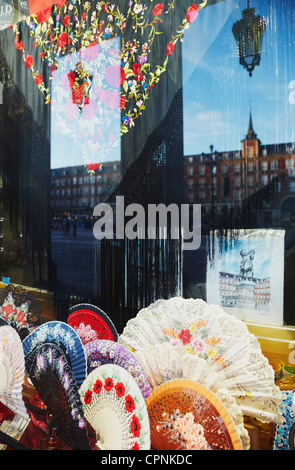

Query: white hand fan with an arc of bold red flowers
<box><xmin>79</xmin><ymin>364</ymin><xmax>150</xmax><ymax>450</ymax></box>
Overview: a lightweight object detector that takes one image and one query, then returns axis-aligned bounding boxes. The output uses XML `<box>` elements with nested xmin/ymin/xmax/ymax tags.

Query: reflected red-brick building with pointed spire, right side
<box><xmin>184</xmin><ymin>112</ymin><xmax>295</xmax><ymax>227</ymax></box>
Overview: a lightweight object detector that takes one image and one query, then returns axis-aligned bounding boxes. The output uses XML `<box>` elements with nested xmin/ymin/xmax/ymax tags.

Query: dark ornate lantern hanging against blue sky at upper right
<box><xmin>232</xmin><ymin>0</ymin><xmax>267</xmax><ymax>77</ymax></box>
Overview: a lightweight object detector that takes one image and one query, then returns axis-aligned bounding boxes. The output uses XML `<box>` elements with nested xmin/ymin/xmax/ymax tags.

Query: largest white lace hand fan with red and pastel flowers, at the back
<box><xmin>118</xmin><ymin>297</ymin><xmax>282</xmax><ymax>422</ymax></box>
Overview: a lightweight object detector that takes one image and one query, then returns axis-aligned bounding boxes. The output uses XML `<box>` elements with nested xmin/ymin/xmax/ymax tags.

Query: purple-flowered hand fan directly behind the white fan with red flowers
<box><xmin>84</xmin><ymin>339</ymin><xmax>151</xmax><ymax>398</ymax></box>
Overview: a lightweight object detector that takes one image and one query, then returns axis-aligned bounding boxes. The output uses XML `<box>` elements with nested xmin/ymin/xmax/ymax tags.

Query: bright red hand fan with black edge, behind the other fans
<box><xmin>67</xmin><ymin>304</ymin><xmax>118</xmax><ymax>344</ymax></box>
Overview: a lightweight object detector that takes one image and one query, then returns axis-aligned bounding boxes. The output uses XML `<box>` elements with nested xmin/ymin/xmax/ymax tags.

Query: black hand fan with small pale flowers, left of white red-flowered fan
<box><xmin>25</xmin><ymin>343</ymin><xmax>91</xmax><ymax>450</ymax></box>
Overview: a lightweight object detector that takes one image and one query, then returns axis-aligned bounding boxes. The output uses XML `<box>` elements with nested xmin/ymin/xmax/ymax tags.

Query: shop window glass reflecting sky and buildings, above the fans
<box><xmin>0</xmin><ymin>0</ymin><xmax>295</xmax><ymax>331</ymax></box>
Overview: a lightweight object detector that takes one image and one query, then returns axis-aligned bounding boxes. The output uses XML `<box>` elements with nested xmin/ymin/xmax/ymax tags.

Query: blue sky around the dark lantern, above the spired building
<box><xmin>183</xmin><ymin>0</ymin><xmax>295</xmax><ymax>155</ymax></box>
